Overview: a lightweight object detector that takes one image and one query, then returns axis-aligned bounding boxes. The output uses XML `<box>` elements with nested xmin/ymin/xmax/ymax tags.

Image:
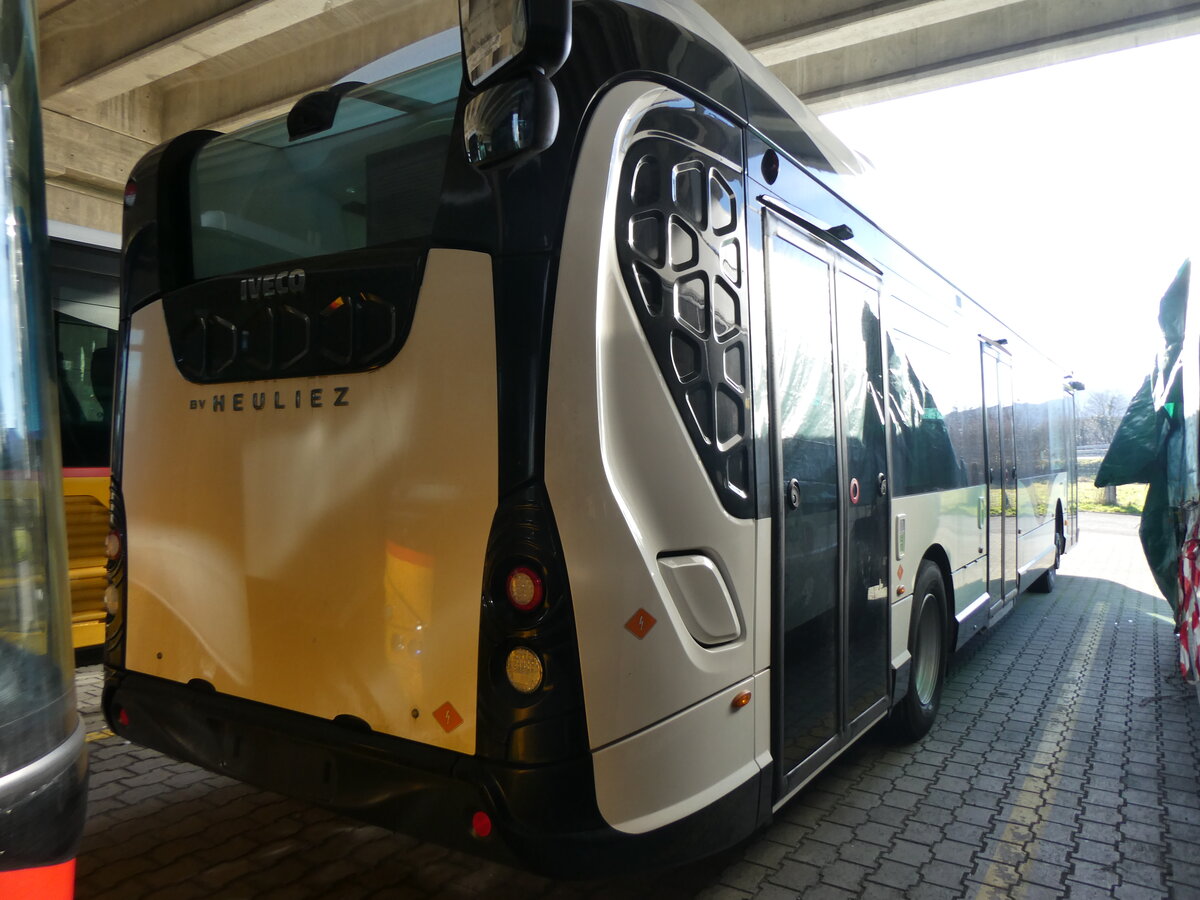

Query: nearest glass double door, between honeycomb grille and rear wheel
<box><xmin>764</xmin><ymin>215</ymin><xmax>888</xmax><ymax>797</ymax></box>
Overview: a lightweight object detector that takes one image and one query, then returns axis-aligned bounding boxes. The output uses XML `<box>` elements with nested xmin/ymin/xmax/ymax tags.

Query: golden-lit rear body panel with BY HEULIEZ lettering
<box><xmin>122</xmin><ymin>251</ymin><xmax>497</xmax><ymax>752</ymax></box>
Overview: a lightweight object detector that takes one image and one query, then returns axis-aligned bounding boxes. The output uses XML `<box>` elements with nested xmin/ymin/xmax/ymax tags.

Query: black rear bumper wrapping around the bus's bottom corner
<box><xmin>103</xmin><ymin>670</ymin><xmax>761</xmax><ymax>878</ymax></box>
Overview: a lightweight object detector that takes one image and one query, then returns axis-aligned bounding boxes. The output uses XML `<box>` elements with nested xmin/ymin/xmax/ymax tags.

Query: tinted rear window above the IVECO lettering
<box><xmin>191</xmin><ymin>56</ymin><xmax>462</xmax><ymax>278</ymax></box>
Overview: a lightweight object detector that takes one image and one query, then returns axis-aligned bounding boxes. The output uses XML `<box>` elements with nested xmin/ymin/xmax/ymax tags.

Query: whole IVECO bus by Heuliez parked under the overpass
<box><xmin>104</xmin><ymin>0</ymin><xmax>1075</xmax><ymax>875</ymax></box>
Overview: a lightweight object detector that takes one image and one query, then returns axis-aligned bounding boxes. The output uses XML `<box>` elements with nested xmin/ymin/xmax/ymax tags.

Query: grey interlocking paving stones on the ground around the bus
<box><xmin>77</xmin><ymin>516</ymin><xmax>1200</xmax><ymax>900</ymax></box>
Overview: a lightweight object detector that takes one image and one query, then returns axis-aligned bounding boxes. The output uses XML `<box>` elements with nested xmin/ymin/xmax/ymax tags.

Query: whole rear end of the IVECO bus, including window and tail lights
<box><xmin>104</xmin><ymin>35</ymin><xmax>657</xmax><ymax>870</ymax></box>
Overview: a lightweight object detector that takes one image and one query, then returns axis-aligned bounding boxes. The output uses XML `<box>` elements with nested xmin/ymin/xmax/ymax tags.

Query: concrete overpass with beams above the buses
<box><xmin>37</xmin><ymin>0</ymin><xmax>1200</xmax><ymax>232</ymax></box>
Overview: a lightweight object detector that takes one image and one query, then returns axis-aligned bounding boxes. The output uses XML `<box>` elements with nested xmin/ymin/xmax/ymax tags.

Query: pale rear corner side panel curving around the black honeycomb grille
<box><xmin>546</xmin><ymin>83</ymin><xmax>767</xmax><ymax>828</ymax></box>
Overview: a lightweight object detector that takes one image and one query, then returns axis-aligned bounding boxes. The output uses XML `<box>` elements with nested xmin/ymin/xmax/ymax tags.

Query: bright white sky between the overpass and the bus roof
<box><xmin>822</xmin><ymin>37</ymin><xmax>1200</xmax><ymax>396</ymax></box>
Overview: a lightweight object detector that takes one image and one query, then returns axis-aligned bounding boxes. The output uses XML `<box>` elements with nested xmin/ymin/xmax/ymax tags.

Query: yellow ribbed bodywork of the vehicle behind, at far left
<box><xmin>62</xmin><ymin>476</ymin><xmax>109</xmax><ymax>649</ymax></box>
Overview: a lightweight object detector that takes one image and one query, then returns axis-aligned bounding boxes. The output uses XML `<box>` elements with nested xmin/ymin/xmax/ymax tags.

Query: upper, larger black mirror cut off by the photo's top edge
<box><xmin>458</xmin><ymin>0</ymin><xmax>571</xmax><ymax>90</ymax></box>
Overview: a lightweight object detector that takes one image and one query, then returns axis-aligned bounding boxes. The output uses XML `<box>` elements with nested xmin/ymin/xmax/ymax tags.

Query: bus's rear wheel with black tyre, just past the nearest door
<box><xmin>892</xmin><ymin>562</ymin><xmax>949</xmax><ymax>743</ymax></box>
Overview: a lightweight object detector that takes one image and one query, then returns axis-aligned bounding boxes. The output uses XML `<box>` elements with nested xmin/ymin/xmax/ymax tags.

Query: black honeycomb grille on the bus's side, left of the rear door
<box><xmin>617</xmin><ymin>137</ymin><xmax>755</xmax><ymax>518</ymax></box>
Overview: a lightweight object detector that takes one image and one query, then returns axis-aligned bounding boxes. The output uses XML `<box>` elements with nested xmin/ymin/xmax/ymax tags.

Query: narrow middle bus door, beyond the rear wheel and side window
<box><xmin>982</xmin><ymin>338</ymin><xmax>1016</xmax><ymax>613</ymax></box>
